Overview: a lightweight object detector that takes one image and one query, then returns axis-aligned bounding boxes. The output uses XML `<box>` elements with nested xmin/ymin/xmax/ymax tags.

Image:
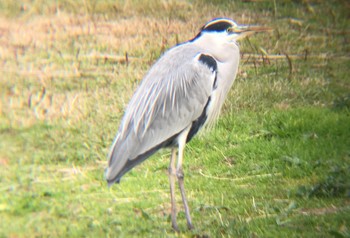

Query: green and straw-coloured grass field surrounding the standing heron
<box><xmin>0</xmin><ymin>0</ymin><xmax>350</xmax><ymax>237</ymax></box>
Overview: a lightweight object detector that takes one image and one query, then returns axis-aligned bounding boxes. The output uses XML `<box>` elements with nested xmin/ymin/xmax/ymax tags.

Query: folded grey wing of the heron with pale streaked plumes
<box><xmin>106</xmin><ymin>51</ymin><xmax>217</xmax><ymax>184</ymax></box>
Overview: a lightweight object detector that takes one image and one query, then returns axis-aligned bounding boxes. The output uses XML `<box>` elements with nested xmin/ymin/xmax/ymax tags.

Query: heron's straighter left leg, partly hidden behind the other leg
<box><xmin>168</xmin><ymin>148</ymin><xmax>179</xmax><ymax>231</ymax></box>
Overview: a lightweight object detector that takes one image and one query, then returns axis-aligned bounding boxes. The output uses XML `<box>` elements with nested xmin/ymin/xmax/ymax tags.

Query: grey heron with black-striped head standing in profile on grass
<box><xmin>105</xmin><ymin>18</ymin><xmax>270</xmax><ymax>230</ymax></box>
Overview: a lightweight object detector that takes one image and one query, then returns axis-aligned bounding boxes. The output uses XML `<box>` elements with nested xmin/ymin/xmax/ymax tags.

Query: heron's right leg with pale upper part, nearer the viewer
<box><xmin>176</xmin><ymin>140</ymin><xmax>193</xmax><ymax>230</ymax></box>
